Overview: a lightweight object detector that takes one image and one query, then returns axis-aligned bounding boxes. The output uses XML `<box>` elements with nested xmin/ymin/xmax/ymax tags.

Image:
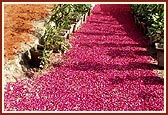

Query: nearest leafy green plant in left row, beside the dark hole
<box><xmin>39</xmin><ymin>26</ymin><xmax>71</xmax><ymax>68</ymax></box>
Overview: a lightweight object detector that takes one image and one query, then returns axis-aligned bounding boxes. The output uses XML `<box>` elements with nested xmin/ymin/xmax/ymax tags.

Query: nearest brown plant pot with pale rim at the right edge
<box><xmin>155</xmin><ymin>43</ymin><xmax>164</xmax><ymax>67</ymax></box>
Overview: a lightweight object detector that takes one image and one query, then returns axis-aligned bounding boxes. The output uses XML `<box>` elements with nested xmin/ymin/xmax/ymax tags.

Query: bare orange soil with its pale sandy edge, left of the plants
<box><xmin>3</xmin><ymin>4</ymin><xmax>53</xmax><ymax>84</ymax></box>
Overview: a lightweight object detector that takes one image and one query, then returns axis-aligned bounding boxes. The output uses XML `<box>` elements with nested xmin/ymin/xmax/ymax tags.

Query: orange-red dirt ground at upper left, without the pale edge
<box><xmin>4</xmin><ymin>4</ymin><xmax>53</xmax><ymax>61</ymax></box>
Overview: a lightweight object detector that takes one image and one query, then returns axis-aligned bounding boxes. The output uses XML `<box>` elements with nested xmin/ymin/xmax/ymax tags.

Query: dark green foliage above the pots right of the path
<box><xmin>130</xmin><ymin>4</ymin><xmax>164</xmax><ymax>43</ymax></box>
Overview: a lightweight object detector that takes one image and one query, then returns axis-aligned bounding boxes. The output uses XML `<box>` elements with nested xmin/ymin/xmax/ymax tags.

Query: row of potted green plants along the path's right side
<box><xmin>131</xmin><ymin>4</ymin><xmax>164</xmax><ymax>67</ymax></box>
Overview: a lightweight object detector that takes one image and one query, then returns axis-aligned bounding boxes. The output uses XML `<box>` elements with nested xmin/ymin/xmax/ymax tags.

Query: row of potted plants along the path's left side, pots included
<box><xmin>25</xmin><ymin>4</ymin><xmax>91</xmax><ymax>69</ymax></box>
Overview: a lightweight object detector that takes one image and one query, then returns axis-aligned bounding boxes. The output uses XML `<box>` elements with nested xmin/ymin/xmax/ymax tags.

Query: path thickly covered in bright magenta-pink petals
<box><xmin>4</xmin><ymin>4</ymin><xmax>164</xmax><ymax>111</ymax></box>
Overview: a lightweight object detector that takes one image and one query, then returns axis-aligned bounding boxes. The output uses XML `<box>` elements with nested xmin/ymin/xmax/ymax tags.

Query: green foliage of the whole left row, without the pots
<box><xmin>39</xmin><ymin>4</ymin><xmax>91</xmax><ymax>68</ymax></box>
